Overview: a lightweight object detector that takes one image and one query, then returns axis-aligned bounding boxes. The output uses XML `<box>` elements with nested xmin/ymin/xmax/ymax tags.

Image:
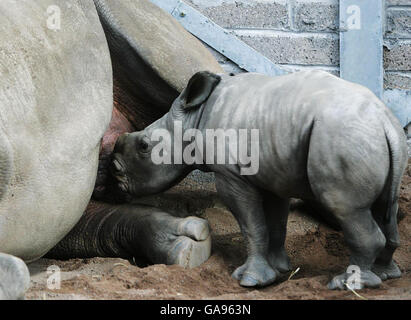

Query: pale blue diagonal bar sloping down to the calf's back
<box><xmin>150</xmin><ymin>0</ymin><xmax>287</xmax><ymax>76</ymax></box>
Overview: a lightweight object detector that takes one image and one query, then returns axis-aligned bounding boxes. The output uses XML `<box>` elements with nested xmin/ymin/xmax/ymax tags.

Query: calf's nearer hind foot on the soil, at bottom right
<box><xmin>327</xmin><ymin>270</ymin><xmax>382</xmax><ymax>290</ymax></box>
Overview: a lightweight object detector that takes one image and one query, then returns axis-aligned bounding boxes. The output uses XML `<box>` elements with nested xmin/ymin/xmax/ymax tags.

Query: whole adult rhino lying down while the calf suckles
<box><xmin>0</xmin><ymin>0</ymin><xmax>222</xmax><ymax>299</ymax></box>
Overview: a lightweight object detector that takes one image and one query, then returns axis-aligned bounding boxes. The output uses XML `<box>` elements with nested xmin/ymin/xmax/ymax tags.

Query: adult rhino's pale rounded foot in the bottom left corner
<box><xmin>0</xmin><ymin>253</ymin><xmax>30</xmax><ymax>300</ymax></box>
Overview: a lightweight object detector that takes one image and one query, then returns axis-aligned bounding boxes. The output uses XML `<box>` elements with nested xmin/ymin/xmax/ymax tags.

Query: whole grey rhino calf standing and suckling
<box><xmin>113</xmin><ymin>71</ymin><xmax>407</xmax><ymax>289</ymax></box>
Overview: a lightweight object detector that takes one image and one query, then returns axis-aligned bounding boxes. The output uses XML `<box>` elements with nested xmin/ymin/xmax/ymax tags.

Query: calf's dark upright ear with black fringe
<box><xmin>180</xmin><ymin>71</ymin><xmax>221</xmax><ymax>110</ymax></box>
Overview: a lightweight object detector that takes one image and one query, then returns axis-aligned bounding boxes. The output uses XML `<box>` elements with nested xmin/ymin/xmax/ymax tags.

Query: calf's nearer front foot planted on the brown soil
<box><xmin>232</xmin><ymin>256</ymin><xmax>278</xmax><ymax>287</ymax></box>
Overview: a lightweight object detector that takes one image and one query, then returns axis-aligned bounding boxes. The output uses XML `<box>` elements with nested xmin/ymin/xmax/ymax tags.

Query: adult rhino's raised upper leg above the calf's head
<box><xmin>94</xmin><ymin>0</ymin><xmax>224</xmax><ymax>130</ymax></box>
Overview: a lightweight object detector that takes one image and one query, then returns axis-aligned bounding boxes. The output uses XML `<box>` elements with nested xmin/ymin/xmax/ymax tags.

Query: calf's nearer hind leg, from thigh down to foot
<box><xmin>307</xmin><ymin>120</ymin><xmax>390</xmax><ymax>289</ymax></box>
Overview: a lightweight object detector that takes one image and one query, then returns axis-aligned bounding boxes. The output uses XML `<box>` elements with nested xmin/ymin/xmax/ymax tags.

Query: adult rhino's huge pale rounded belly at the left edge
<box><xmin>0</xmin><ymin>0</ymin><xmax>112</xmax><ymax>260</ymax></box>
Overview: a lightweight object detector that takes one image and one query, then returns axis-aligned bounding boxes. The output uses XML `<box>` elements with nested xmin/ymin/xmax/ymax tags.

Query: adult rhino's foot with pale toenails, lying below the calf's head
<box><xmin>151</xmin><ymin>217</ymin><xmax>211</xmax><ymax>268</ymax></box>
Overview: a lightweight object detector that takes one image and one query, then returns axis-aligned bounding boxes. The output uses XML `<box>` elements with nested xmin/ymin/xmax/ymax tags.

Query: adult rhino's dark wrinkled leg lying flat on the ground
<box><xmin>47</xmin><ymin>202</ymin><xmax>211</xmax><ymax>268</ymax></box>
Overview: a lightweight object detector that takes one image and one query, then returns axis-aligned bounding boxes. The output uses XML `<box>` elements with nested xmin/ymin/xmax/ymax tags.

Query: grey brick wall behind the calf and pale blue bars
<box><xmin>184</xmin><ymin>0</ymin><xmax>411</xmax><ymax>90</ymax></box>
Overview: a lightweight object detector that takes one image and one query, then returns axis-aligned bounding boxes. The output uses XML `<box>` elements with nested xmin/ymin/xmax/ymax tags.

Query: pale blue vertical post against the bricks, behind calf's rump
<box><xmin>340</xmin><ymin>0</ymin><xmax>385</xmax><ymax>98</ymax></box>
